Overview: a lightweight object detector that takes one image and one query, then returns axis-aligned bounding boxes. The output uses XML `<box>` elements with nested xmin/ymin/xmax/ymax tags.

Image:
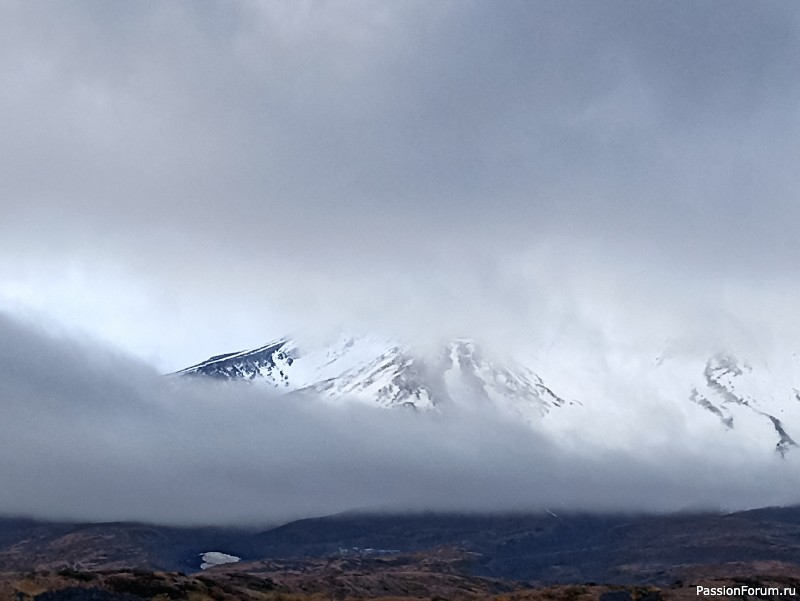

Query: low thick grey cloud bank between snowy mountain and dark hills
<box><xmin>0</xmin><ymin>315</ymin><xmax>800</xmax><ymax>524</ymax></box>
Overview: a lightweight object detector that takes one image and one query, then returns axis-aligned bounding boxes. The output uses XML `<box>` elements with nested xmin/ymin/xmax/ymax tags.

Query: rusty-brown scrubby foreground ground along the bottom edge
<box><xmin>0</xmin><ymin>551</ymin><xmax>800</xmax><ymax>601</ymax></box>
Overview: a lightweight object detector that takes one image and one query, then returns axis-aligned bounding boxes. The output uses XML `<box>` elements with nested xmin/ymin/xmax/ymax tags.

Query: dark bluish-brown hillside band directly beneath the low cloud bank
<box><xmin>0</xmin><ymin>507</ymin><xmax>800</xmax><ymax>584</ymax></box>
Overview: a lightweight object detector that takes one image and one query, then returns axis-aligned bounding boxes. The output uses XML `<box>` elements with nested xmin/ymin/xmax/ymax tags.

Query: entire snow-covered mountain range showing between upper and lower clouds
<box><xmin>177</xmin><ymin>336</ymin><xmax>800</xmax><ymax>456</ymax></box>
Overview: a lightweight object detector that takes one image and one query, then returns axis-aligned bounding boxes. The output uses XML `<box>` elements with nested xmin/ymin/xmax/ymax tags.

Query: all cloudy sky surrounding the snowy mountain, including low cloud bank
<box><xmin>0</xmin><ymin>0</ymin><xmax>800</xmax><ymax>522</ymax></box>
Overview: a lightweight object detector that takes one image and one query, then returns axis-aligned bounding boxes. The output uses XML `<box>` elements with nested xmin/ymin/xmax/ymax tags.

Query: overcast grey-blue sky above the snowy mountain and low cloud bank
<box><xmin>0</xmin><ymin>0</ymin><xmax>800</xmax><ymax>371</ymax></box>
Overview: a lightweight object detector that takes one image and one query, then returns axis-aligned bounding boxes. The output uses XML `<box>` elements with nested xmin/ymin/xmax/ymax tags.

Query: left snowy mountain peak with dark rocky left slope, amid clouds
<box><xmin>177</xmin><ymin>337</ymin><xmax>565</xmax><ymax>420</ymax></box>
